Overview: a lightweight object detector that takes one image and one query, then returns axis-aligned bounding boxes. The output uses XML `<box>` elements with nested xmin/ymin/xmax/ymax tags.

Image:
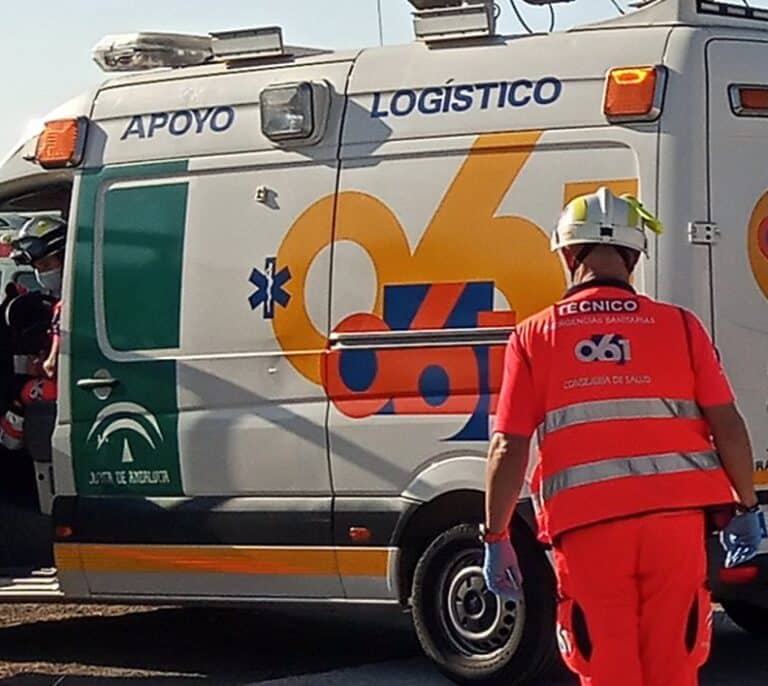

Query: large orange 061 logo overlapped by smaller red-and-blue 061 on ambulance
<box><xmin>273</xmin><ymin>131</ymin><xmax>637</xmax><ymax>440</ymax></box>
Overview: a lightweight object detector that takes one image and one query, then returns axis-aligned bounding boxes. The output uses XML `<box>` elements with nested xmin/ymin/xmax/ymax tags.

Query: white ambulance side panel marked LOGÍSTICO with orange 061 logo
<box><xmin>326</xmin><ymin>30</ymin><xmax>669</xmax><ymax>591</ymax></box>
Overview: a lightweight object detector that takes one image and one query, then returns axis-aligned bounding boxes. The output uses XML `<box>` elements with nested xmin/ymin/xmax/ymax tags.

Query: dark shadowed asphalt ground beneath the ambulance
<box><xmin>0</xmin><ymin>608</ymin><xmax>768</xmax><ymax>686</ymax></box>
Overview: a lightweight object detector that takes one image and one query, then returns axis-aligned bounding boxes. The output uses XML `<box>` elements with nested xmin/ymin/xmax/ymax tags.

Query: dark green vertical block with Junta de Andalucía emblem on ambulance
<box><xmin>71</xmin><ymin>163</ymin><xmax>188</xmax><ymax>496</ymax></box>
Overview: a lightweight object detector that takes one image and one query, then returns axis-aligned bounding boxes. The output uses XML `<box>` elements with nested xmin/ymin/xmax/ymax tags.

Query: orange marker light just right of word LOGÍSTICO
<box><xmin>603</xmin><ymin>67</ymin><xmax>666</xmax><ymax>122</ymax></box>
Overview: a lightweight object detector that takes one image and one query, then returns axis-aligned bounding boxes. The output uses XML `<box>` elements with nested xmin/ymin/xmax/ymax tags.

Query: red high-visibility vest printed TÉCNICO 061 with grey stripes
<box><xmin>519</xmin><ymin>288</ymin><xmax>733</xmax><ymax>541</ymax></box>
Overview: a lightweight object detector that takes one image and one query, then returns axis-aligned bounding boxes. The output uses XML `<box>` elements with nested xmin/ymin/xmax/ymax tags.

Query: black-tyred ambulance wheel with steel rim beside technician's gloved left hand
<box><xmin>412</xmin><ymin>524</ymin><xmax>557</xmax><ymax>686</ymax></box>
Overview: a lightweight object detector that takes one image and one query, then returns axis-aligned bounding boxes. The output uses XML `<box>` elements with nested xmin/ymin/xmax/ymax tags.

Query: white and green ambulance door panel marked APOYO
<box><xmin>57</xmin><ymin>61</ymin><xmax>368</xmax><ymax>598</ymax></box>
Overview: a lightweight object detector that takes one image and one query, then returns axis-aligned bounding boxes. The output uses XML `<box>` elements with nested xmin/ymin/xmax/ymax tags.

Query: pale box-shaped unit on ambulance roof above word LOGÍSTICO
<box><xmin>409</xmin><ymin>0</ymin><xmax>496</xmax><ymax>43</ymax></box>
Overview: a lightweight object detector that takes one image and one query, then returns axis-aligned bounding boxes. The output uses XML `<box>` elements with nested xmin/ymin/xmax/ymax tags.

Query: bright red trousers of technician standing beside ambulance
<box><xmin>555</xmin><ymin>511</ymin><xmax>712</xmax><ymax>686</ymax></box>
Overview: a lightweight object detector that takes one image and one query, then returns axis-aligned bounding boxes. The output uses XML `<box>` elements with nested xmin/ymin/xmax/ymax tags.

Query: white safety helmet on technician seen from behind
<box><xmin>551</xmin><ymin>187</ymin><xmax>664</xmax><ymax>255</ymax></box>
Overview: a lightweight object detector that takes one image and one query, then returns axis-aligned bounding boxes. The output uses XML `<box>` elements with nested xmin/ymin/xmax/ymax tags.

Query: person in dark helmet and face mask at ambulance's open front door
<box><xmin>0</xmin><ymin>216</ymin><xmax>67</xmax><ymax>450</ymax></box>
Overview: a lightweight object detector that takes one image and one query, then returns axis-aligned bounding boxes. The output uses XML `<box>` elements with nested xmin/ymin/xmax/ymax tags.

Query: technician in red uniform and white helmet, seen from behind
<box><xmin>484</xmin><ymin>188</ymin><xmax>760</xmax><ymax>686</ymax></box>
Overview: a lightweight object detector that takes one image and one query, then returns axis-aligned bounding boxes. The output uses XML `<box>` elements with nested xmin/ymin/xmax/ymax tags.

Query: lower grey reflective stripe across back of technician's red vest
<box><xmin>539</xmin><ymin>451</ymin><xmax>722</xmax><ymax>502</ymax></box>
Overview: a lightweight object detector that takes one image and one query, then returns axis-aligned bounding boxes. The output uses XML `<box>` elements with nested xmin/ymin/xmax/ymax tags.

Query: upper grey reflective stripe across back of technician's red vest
<box><xmin>537</xmin><ymin>398</ymin><xmax>701</xmax><ymax>440</ymax></box>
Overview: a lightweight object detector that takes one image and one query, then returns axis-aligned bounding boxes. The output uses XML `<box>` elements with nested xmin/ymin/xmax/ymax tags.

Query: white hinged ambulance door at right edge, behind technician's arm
<box><xmin>704</xmin><ymin>39</ymin><xmax>768</xmax><ymax>487</ymax></box>
